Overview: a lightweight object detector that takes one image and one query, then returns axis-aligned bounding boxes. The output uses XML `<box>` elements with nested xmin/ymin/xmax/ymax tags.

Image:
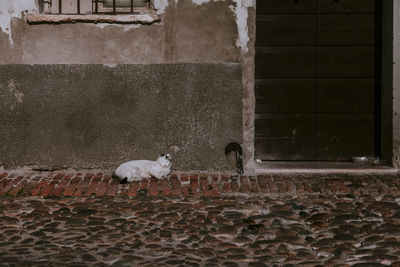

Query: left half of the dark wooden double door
<box><xmin>255</xmin><ymin>0</ymin><xmax>316</xmax><ymax>160</ymax></box>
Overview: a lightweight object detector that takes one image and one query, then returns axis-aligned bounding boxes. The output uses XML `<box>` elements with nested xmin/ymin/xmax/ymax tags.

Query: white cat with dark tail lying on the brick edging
<box><xmin>113</xmin><ymin>154</ymin><xmax>172</xmax><ymax>183</ymax></box>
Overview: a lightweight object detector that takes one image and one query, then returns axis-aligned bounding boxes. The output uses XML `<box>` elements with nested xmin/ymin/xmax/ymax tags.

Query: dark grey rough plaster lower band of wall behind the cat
<box><xmin>0</xmin><ymin>64</ymin><xmax>242</xmax><ymax>171</ymax></box>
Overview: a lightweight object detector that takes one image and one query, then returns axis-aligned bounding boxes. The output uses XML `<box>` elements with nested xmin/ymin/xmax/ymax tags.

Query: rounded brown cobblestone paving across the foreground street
<box><xmin>0</xmin><ymin>175</ymin><xmax>400</xmax><ymax>266</ymax></box>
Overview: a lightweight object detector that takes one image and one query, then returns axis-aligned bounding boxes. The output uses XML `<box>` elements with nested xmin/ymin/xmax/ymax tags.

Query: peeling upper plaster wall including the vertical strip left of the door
<box><xmin>0</xmin><ymin>0</ymin><xmax>255</xmax><ymax>171</ymax></box>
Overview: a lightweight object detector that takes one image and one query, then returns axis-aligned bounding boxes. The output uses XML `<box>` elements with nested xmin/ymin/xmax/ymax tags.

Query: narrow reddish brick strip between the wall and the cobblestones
<box><xmin>0</xmin><ymin>170</ymin><xmax>400</xmax><ymax>198</ymax></box>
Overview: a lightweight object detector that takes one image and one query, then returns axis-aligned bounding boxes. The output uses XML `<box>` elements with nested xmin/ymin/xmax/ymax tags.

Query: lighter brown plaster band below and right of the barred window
<box><xmin>0</xmin><ymin>0</ymin><xmax>241</xmax><ymax>64</ymax></box>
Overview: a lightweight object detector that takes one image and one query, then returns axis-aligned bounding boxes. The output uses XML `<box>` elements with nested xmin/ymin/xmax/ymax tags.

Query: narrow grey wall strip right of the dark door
<box><xmin>393</xmin><ymin>0</ymin><xmax>400</xmax><ymax>168</ymax></box>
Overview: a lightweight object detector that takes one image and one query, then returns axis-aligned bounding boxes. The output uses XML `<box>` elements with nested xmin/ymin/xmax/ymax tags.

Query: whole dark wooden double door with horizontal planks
<box><xmin>255</xmin><ymin>0</ymin><xmax>380</xmax><ymax>161</ymax></box>
